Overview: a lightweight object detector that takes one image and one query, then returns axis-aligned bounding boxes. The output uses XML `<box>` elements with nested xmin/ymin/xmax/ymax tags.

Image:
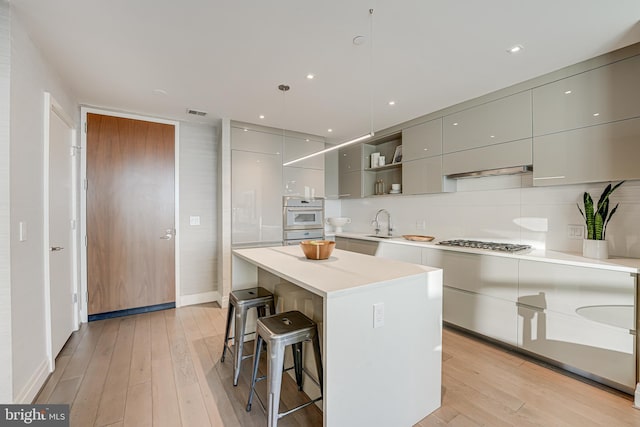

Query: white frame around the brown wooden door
<box><xmin>80</xmin><ymin>105</ymin><xmax>182</xmax><ymax>323</ymax></box>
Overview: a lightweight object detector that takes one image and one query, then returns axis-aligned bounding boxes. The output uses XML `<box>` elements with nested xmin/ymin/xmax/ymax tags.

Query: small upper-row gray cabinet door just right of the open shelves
<box><xmin>402</xmin><ymin>118</ymin><xmax>442</xmax><ymax>162</ymax></box>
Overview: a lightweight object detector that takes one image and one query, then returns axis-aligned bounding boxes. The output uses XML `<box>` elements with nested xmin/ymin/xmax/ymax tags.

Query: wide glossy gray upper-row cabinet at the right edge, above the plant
<box><xmin>533</xmin><ymin>56</ymin><xmax>640</xmax><ymax>136</ymax></box>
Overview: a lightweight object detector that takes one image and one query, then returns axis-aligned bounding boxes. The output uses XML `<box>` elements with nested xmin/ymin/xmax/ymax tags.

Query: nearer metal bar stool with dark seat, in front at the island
<box><xmin>247</xmin><ymin>311</ymin><xmax>322</xmax><ymax>427</ymax></box>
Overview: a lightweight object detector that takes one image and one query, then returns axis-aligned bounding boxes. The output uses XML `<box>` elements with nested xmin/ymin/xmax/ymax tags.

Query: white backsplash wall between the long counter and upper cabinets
<box><xmin>341</xmin><ymin>174</ymin><xmax>640</xmax><ymax>258</ymax></box>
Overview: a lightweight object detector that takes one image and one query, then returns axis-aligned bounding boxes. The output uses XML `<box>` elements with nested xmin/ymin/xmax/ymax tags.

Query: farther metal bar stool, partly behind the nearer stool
<box><xmin>220</xmin><ymin>287</ymin><xmax>276</xmax><ymax>386</ymax></box>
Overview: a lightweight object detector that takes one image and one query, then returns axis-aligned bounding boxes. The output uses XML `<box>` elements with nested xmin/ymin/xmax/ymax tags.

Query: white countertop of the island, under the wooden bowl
<box><xmin>233</xmin><ymin>246</ymin><xmax>438</xmax><ymax>297</ymax></box>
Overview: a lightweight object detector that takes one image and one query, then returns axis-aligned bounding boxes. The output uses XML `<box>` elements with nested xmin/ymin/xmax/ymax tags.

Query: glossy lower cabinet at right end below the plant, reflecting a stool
<box><xmin>518</xmin><ymin>260</ymin><xmax>636</xmax><ymax>392</ymax></box>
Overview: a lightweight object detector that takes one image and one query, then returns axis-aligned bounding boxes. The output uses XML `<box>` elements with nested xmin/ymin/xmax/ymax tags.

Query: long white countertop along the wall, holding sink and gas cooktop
<box><xmin>336</xmin><ymin>232</ymin><xmax>640</xmax><ymax>273</ymax></box>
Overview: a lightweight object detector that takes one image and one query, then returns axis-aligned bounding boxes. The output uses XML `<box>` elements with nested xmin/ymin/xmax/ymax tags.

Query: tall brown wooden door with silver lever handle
<box><xmin>87</xmin><ymin>114</ymin><xmax>175</xmax><ymax>315</ymax></box>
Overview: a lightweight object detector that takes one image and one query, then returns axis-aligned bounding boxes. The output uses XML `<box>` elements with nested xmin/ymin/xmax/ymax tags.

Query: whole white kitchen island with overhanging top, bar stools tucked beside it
<box><xmin>232</xmin><ymin>246</ymin><xmax>442</xmax><ymax>426</ymax></box>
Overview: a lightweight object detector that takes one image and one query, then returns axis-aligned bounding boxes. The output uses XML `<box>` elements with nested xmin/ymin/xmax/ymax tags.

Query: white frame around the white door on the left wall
<box><xmin>42</xmin><ymin>92</ymin><xmax>80</xmax><ymax>372</ymax></box>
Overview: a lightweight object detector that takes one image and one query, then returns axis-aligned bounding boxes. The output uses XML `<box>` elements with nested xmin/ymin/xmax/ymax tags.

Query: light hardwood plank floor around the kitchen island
<box><xmin>36</xmin><ymin>304</ymin><xmax>640</xmax><ymax>427</ymax></box>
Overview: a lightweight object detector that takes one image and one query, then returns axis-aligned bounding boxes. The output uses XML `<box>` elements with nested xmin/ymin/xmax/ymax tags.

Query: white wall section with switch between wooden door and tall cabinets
<box><xmin>180</xmin><ymin>123</ymin><xmax>218</xmax><ymax>299</ymax></box>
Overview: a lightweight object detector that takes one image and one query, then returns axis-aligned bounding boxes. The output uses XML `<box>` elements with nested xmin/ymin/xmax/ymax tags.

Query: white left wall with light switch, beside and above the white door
<box><xmin>9</xmin><ymin>8</ymin><xmax>79</xmax><ymax>400</ymax></box>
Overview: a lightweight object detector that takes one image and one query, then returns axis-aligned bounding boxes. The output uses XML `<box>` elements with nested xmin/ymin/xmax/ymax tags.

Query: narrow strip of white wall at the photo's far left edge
<box><xmin>0</xmin><ymin>0</ymin><xmax>13</xmax><ymax>403</ymax></box>
